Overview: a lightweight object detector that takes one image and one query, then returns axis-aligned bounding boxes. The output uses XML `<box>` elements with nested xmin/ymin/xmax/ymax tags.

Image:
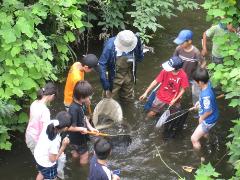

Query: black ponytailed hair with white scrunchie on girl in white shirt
<box><xmin>46</xmin><ymin>111</ymin><xmax>71</xmax><ymax>141</ymax></box>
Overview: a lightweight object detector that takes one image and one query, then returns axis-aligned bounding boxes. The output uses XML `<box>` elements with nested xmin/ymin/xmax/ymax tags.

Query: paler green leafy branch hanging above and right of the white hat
<box><xmin>128</xmin><ymin>0</ymin><xmax>198</xmax><ymax>42</ymax></box>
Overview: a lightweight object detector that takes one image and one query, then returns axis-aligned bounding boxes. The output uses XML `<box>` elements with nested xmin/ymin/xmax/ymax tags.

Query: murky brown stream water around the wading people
<box><xmin>0</xmin><ymin>5</ymin><xmax>237</xmax><ymax>180</ymax></box>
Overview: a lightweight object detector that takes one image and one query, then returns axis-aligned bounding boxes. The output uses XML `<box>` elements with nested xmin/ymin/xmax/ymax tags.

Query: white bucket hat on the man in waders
<box><xmin>114</xmin><ymin>30</ymin><xmax>137</xmax><ymax>53</ymax></box>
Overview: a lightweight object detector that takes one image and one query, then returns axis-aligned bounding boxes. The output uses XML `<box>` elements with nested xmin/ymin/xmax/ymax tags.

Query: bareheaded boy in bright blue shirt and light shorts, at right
<box><xmin>191</xmin><ymin>68</ymin><xmax>219</xmax><ymax>150</ymax></box>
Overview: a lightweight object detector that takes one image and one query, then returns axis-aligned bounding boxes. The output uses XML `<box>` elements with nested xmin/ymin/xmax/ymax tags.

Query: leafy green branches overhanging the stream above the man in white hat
<box><xmin>89</xmin><ymin>0</ymin><xmax>198</xmax><ymax>43</ymax></box>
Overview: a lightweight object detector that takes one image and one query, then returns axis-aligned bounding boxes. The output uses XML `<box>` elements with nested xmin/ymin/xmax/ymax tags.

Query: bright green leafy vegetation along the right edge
<box><xmin>196</xmin><ymin>0</ymin><xmax>240</xmax><ymax>179</ymax></box>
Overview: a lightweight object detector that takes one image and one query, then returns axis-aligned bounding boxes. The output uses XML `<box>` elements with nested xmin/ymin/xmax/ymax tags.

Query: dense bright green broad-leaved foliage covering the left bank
<box><xmin>0</xmin><ymin>0</ymin><xmax>85</xmax><ymax>149</ymax></box>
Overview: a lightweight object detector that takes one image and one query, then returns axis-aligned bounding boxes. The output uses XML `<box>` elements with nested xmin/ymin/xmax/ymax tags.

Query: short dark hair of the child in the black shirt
<box><xmin>73</xmin><ymin>81</ymin><xmax>93</xmax><ymax>100</ymax></box>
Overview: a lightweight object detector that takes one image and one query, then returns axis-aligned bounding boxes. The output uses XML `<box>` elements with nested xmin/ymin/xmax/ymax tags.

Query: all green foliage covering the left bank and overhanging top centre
<box><xmin>0</xmin><ymin>0</ymin><xmax>197</xmax><ymax>150</ymax></box>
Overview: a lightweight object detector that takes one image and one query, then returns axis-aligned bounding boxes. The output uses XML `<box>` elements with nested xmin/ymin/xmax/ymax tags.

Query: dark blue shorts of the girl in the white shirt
<box><xmin>37</xmin><ymin>163</ymin><xmax>57</xmax><ymax>179</ymax></box>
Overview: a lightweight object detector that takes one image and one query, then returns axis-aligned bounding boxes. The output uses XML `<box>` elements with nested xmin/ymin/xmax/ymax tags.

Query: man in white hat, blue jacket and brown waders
<box><xmin>99</xmin><ymin>30</ymin><xmax>143</xmax><ymax>101</ymax></box>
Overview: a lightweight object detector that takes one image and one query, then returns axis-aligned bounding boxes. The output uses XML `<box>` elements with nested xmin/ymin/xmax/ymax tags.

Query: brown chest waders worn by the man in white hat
<box><xmin>112</xmin><ymin>53</ymin><xmax>136</xmax><ymax>101</ymax></box>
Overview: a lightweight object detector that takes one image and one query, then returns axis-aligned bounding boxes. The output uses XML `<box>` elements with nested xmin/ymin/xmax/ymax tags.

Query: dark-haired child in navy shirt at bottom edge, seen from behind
<box><xmin>89</xmin><ymin>138</ymin><xmax>120</xmax><ymax>180</ymax></box>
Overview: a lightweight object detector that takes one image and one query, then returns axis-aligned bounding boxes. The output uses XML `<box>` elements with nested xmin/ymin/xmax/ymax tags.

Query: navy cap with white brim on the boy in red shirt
<box><xmin>162</xmin><ymin>56</ymin><xmax>183</xmax><ymax>72</ymax></box>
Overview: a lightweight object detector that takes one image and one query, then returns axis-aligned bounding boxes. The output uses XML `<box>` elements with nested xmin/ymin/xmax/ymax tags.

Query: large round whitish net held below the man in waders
<box><xmin>93</xmin><ymin>98</ymin><xmax>123</xmax><ymax>129</ymax></box>
